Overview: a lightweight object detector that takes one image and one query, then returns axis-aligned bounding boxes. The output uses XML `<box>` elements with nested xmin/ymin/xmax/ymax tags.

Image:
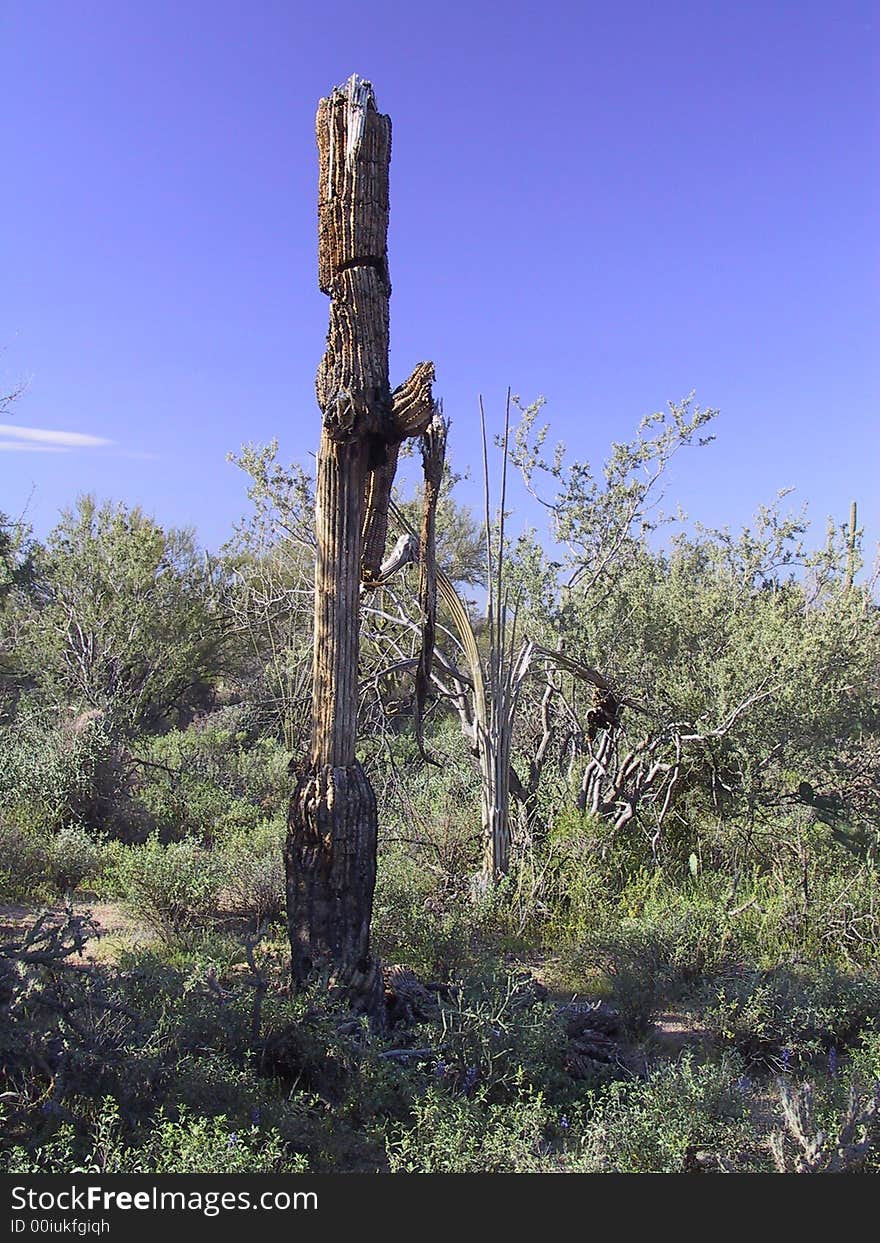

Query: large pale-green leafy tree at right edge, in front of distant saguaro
<box><xmin>563</xmin><ymin>508</ymin><xmax>880</xmax><ymax>835</ymax></box>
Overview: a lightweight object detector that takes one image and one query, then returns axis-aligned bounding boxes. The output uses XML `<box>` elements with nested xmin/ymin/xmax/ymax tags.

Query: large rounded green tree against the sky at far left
<box><xmin>16</xmin><ymin>496</ymin><xmax>222</xmax><ymax>736</ymax></box>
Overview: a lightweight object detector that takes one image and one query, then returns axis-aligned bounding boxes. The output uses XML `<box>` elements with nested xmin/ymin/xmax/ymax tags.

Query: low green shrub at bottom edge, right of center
<box><xmin>582</xmin><ymin>1057</ymin><xmax>766</xmax><ymax>1173</ymax></box>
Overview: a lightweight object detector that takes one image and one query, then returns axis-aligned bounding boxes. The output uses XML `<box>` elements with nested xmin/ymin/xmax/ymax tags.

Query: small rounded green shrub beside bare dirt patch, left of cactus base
<box><xmin>117</xmin><ymin>834</ymin><xmax>226</xmax><ymax>945</ymax></box>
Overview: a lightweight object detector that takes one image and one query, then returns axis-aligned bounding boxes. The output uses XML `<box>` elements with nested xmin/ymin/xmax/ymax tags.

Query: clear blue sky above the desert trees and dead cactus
<box><xmin>0</xmin><ymin>0</ymin><xmax>880</xmax><ymax>564</ymax></box>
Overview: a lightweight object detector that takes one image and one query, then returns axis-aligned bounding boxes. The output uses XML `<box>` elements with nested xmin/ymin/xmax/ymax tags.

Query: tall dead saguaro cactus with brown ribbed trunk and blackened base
<box><xmin>285</xmin><ymin>75</ymin><xmax>435</xmax><ymax>1016</ymax></box>
